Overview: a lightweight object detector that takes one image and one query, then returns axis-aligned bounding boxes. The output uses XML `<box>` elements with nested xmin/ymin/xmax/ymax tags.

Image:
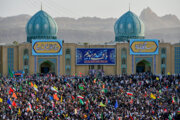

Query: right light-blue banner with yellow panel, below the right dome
<box><xmin>130</xmin><ymin>39</ymin><xmax>159</xmax><ymax>55</ymax></box>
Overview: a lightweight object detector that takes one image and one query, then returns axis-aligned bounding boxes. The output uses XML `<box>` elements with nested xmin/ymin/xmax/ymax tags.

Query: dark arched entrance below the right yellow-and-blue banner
<box><xmin>136</xmin><ymin>60</ymin><xmax>151</xmax><ymax>73</ymax></box>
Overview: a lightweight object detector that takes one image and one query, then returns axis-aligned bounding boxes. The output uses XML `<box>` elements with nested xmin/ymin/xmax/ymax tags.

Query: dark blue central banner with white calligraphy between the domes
<box><xmin>76</xmin><ymin>48</ymin><xmax>116</xmax><ymax>65</ymax></box>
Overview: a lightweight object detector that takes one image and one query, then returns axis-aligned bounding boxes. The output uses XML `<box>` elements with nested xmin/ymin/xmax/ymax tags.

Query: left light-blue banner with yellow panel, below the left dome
<box><xmin>32</xmin><ymin>40</ymin><xmax>62</xmax><ymax>55</ymax></box>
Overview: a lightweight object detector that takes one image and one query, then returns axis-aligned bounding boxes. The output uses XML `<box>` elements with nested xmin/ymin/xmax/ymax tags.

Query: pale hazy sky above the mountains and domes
<box><xmin>0</xmin><ymin>0</ymin><xmax>180</xmax><ymax>18</ymax></box>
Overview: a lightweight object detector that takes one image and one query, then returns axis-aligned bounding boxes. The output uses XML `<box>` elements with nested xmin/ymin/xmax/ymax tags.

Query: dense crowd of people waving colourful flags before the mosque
<box><xmin>0</xmin><ymin>73</ymin><xmax>180</xmax><ymax>120</ymax></box>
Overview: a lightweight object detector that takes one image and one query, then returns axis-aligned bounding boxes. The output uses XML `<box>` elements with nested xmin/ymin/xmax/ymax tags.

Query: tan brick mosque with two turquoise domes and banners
<box><xmin>0</xmin><ymin>10</ymin><xmax>180</xmax><ymax>75</ymax></box>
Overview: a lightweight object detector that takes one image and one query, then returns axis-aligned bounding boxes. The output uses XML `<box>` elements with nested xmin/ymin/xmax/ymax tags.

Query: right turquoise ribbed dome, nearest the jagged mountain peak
<box><xmin>114</xmin><ymin>11</ymin><xmax>144</xmax><ymax>42</ymax></box>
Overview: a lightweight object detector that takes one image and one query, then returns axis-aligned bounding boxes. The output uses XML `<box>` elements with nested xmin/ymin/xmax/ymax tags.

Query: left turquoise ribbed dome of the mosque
<box><xmin>26</xmin><ymin>10</ymin><xmax>58</xmax><ymax>42</ymax></box>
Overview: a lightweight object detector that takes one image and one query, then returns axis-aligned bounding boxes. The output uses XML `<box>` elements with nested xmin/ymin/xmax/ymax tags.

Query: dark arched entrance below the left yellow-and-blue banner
<box><xmin>40</xmin><ymin>61</ymin><xmax>55</xmax><ymax>74</ymax></box>
